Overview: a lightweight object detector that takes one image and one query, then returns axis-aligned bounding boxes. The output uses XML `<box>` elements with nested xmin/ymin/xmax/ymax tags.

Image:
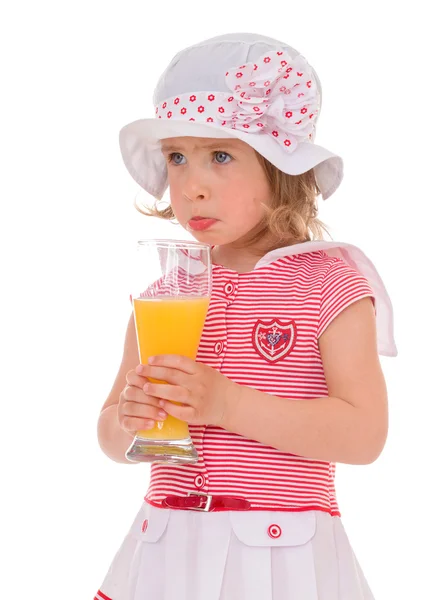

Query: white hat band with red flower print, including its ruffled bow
<box><xmin>156</xmin><ymin>50</ymin><xmax>320</xmax><ymax>153</ymax></box>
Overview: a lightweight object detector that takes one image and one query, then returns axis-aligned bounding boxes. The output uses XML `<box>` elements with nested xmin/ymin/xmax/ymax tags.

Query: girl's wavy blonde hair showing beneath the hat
<box><xmin>134</xmin><ymin>151</ymin><xmax>332</xmax><ymax>256</ymax></box>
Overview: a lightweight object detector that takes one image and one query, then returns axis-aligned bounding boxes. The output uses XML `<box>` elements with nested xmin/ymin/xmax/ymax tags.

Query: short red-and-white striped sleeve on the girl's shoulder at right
<box><xmin>317</xmin><ymin>258</ymin><xmax>376</xmax><ymax>339</ymax></box>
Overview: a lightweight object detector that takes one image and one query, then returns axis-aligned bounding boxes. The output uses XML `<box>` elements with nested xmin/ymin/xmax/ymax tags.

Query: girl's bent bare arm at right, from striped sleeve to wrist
<box><xmin>222</xmin><ymin>297</ymin><xmax>388</xmax><ymax>464</ymax></box>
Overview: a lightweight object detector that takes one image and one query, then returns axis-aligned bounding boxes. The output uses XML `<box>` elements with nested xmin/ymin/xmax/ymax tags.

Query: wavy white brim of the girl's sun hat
<box><xmin>119</xmin><ymin>118</ymin><xmax>343</xmax><ymax>200</ymax></box>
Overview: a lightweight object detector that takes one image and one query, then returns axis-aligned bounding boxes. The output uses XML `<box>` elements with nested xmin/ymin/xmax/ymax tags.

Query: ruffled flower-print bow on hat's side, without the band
<box><xmin>222</xmin><ymin>51</ymin><xmax>320</xmax><ymax>151</ymax></box>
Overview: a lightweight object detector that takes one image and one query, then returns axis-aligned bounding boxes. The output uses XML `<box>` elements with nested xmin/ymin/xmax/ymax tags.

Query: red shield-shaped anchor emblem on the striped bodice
<box><xmin>252</xmin><ymin>319</ymin><xmax>296</xmax><ymax>363</ymax></box>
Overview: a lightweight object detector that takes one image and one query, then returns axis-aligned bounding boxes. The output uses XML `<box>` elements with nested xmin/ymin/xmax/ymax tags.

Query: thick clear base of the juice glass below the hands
<box><xmin>125</xmin><ymin>436</ymin><xmax>199</xmax><ymax>465</ymax></box>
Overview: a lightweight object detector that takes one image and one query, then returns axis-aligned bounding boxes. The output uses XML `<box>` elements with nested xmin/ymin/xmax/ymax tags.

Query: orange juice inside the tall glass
<box><xmin>133</xmin><ymin>296</ymin><xmax>209</xmax><ymax>440</ymax></box>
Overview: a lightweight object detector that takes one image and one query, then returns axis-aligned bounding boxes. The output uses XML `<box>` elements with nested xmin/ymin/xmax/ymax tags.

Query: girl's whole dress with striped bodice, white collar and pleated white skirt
<box><xmin>95</xmin><ymin>241</ymin><xmax>397</xmax><ymax>600</ymax></box>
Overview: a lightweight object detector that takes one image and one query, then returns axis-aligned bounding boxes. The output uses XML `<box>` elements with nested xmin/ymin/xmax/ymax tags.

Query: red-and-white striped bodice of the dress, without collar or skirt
<box><xmin>145</xmin><ymin>247</ymin><xmax>375</xmax><ymax>516</ymax></box>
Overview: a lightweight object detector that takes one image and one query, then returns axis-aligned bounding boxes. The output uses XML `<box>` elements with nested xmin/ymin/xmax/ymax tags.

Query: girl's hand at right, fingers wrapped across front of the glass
<box><xmin>137</xmin><ymin>354</ymin><xmax>241</xmax><ymax>427</ymax></box>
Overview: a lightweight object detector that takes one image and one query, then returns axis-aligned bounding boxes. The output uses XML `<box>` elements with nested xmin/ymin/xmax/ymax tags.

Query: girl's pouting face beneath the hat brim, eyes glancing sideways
<box><xmin>161</xmin><ymin>137</ymin><xmax>271</xmax><ymax>246</ymax></box>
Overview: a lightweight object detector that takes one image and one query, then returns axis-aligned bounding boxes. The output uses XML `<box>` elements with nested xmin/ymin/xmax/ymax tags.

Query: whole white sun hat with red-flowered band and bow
<box><xmin>120</xmin><ymin>33</ymin><xmax>343</xmax><ymax>200</ymax></box>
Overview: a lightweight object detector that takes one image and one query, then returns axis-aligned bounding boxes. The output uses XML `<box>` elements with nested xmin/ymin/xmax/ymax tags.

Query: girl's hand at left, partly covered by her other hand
<box><xmin>118</xmin><ymin>369</ymin><xmax>167</xmax><ymax>436</ymax></box>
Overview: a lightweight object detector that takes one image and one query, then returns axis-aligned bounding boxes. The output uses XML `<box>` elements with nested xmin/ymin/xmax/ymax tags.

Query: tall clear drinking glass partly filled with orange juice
<box><xmin>126</xmin><ymin>239</ymin><xmax>212</xmax><ymax>464</ymax></box>
